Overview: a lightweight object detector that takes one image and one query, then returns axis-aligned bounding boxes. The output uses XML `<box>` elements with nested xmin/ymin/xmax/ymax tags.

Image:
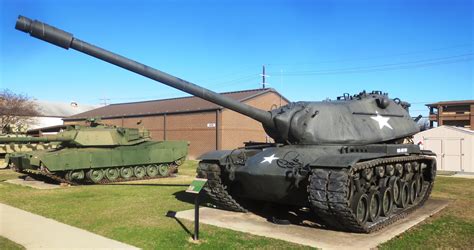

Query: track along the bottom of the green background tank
<box><xmin>20</xmin><ymin>165</ymin><xmax>178</xmax><ymax>186</ymax></box>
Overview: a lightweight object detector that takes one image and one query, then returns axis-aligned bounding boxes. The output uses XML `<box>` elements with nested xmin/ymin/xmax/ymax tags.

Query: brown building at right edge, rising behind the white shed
<box><xmin>426</xmin><ymin>100</ymin><xmax>474</xmax><ymax>130</ymax></box>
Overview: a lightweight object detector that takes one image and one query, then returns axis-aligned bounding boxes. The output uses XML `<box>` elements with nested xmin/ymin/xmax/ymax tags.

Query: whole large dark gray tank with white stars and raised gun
<box><xmin>16</xmin><ymin>16</ymin><xmax>436</xmax><ymax>233</ymax></box>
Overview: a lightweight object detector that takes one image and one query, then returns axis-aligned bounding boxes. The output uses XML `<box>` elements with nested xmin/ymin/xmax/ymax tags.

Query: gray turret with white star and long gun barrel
<box><xmin>15</xmin><ymin>16</ymin><xmax>419</xmax><ymax>145</ymax></box>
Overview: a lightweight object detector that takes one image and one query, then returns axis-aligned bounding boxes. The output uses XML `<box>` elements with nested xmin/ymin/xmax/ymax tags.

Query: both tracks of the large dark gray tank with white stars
<box><xmin>197</xmin><ymin>155</ymin><xmax>435</xmax><ymax>233</ymax></box>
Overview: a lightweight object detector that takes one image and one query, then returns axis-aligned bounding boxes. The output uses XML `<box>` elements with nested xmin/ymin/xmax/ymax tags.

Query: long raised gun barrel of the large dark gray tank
<box><xmin>15</xmin><ymin>16</ymin><xmax>273</xmax><ymax>127</ymax></box>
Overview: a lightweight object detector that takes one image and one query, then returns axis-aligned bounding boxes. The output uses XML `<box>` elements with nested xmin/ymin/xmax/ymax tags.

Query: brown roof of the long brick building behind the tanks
<box><xmin>63</xmin><ymin>88</ymin><xmax>289</xmax><ymax>121</ymax></box>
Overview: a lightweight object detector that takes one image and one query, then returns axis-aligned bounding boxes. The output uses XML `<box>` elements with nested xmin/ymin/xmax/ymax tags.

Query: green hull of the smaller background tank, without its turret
<box><xmin>7</xmin><ymin>141</ymin><xmax>188</xmax><ymax>182</ymax></box>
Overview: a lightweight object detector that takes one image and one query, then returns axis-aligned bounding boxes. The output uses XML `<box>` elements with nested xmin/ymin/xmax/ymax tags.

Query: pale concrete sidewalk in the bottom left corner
<box><xmin>0</xmin><ymin>203</ymin><xmax>138</xmax><ymax>249</ymax></box>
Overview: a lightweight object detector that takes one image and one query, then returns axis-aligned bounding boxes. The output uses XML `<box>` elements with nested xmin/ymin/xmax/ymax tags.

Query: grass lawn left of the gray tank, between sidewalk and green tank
<box><xmin>0</xmin><ymin>161</ymin><xmax>305</xmax><ymax>249</ymax></box>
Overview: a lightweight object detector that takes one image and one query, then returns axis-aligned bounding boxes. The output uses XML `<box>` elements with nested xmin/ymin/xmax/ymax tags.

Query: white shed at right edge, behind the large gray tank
<box><xmin>415</xmin><ymin>126</ymin><xmax>474</xmax><ymax>173</ymax></box>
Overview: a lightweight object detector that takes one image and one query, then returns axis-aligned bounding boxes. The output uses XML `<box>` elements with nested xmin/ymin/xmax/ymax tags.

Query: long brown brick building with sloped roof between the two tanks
<box><xmin>63</xmin><ymin>88</ymin><xmax>288</xmax><ymax>159</ymax></box>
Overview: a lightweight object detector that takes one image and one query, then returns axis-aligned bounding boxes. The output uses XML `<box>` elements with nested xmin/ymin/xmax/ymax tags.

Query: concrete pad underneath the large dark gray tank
<box><xmin>176</xmin><ymin>199</ymin><xmax>449</xmax><ymax>249</ymax></box>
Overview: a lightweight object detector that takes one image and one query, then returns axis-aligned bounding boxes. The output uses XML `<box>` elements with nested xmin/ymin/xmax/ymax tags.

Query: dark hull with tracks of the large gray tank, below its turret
<box><xmin>198</xmin><ymin>144</ymin><xmax>436</xmax><ymax>233</ymax></box>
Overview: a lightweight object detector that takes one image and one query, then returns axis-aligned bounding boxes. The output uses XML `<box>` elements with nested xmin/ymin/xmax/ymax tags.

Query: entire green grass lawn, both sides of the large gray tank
<box><xmin>0</xmin><ymin>161</ymin><xmax>474</xmax><ymax>249</ymax></box>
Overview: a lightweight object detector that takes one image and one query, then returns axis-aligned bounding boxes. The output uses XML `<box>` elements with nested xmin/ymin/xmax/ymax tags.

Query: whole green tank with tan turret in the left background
<box><xmin>4</xmin><ymin>122</ymin><xmax>188</xmax><ymax>185</ymax></box>
